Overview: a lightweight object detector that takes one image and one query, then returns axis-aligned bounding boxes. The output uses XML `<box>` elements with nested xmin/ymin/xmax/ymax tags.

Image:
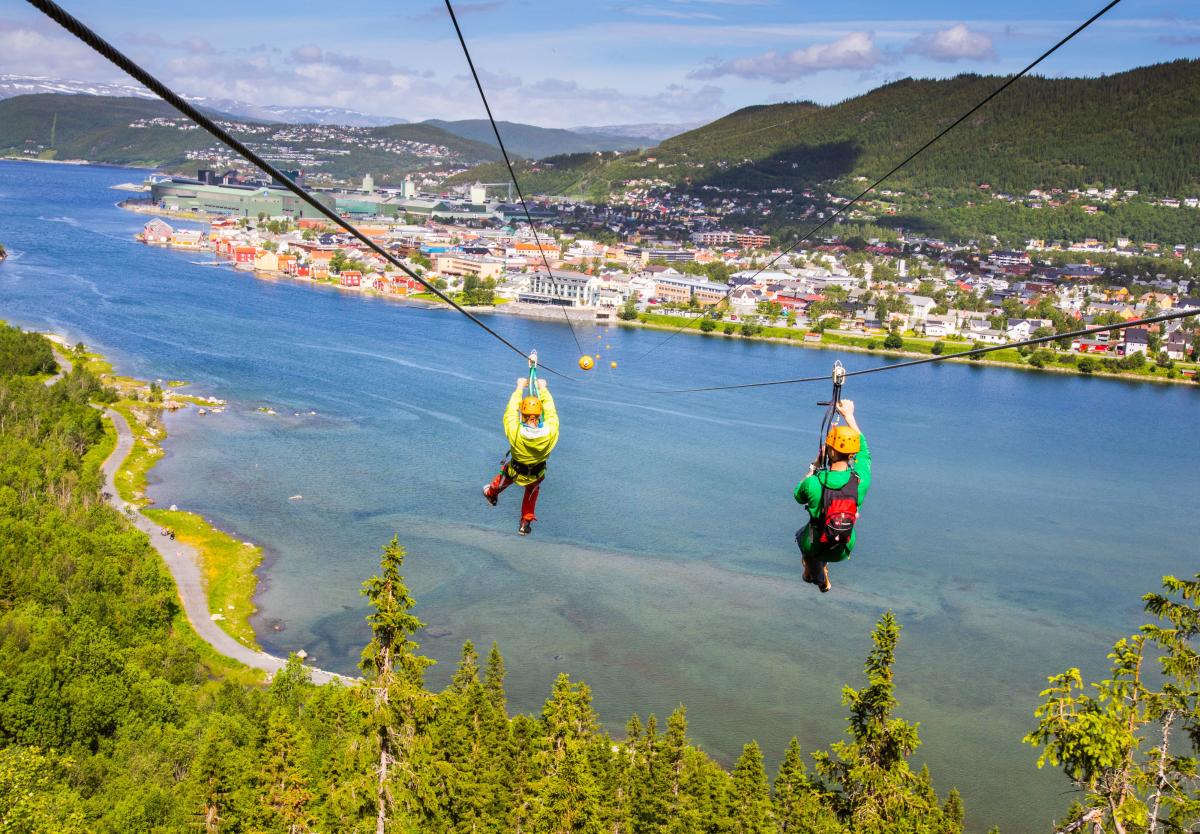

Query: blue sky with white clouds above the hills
<box><xmin>0</xmin><ymin>0</ymin><xmax>1200</xmax><ymax>127</ymax></box>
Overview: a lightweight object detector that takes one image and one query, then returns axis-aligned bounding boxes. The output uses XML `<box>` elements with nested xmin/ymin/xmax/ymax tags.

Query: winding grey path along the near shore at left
<box><xmin>46</xmin><ymin>352</ymin><xmax>349</xmax><ymax>684</ymax></box>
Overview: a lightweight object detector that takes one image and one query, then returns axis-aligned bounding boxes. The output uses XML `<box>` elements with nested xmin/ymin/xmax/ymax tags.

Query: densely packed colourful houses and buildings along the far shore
<box><xmin>140</xmin><ymin>212</ymin><xmax>1200</xmax><ymax>359</ymax></box>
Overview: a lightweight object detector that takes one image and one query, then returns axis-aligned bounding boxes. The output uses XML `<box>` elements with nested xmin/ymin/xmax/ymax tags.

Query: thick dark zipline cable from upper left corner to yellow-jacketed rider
<box><xmin>22</xmin><ymin>0</ymin><xmax>574</xmax><ymax>379</ymax></box>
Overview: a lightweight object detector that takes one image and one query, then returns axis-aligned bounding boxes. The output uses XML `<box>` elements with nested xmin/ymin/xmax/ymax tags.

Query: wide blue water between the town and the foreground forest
<box><xmin>0</xmin><ymin>162</ymin><xmax>1200</xmax><ymax>832</ymax></box>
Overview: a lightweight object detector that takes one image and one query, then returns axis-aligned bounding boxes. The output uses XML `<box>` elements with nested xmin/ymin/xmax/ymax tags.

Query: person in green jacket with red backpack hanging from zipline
<box><xmin>793</xmin><ymin>400</ymin><xmax>871</xmax><ymax>593</ymax></box>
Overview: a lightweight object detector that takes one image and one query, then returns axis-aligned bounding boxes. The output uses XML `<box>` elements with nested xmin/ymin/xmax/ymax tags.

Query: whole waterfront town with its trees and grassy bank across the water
<box><xmin>125</xmin><ymin>169</ymin><xmax>1200</xmax><ymax>379</ymax></box>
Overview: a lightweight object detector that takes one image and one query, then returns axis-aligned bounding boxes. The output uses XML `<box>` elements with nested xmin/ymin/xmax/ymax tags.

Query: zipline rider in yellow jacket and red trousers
<box><xmin>484</xmin><ymin>377</ymin><xmax>558</xmax><ymax>535</ymax></box>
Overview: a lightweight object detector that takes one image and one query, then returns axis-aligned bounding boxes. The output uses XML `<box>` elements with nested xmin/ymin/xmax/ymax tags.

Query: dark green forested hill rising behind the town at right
<box><xmin>448</xmin><ymin>60</ymin><xmax>1200</xmax><ymax>196</ymax></box>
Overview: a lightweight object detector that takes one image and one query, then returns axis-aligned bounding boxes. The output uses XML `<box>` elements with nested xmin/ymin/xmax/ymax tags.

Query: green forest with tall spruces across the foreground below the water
<box><xmin>0</xmin><ymin>328</ymin><xmax>1200</xmax><ymax>834</ymax></box>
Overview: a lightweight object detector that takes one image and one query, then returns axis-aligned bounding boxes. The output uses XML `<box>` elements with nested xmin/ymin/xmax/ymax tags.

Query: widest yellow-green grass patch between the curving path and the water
<box><xmin>142</xmin><ymin>510</ymin><xmax>263</xmax><ymax>649</ymax></box>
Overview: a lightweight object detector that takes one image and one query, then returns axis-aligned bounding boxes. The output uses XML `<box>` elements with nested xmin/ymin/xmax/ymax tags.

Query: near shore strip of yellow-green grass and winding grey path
<box><xmin>42</xmin><ymin>332</ymin><xmax>346</xmax><ymax>684</ymax></box>
